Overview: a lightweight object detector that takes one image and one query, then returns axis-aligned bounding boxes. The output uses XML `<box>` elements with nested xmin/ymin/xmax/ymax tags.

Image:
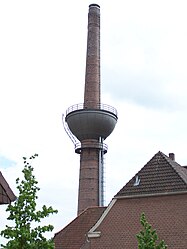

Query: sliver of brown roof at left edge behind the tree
<box><xmin>0</xmin><ymin>171</ymin><xmax>16</xmax><ymax>204</ymax></box>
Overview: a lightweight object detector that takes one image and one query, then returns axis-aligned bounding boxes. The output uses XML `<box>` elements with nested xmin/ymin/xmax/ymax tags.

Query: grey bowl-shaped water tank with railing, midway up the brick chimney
<box><xmin>66</xmin><ymin>104</ymin><xmax>118</xmax><ymax>141</ymax></box>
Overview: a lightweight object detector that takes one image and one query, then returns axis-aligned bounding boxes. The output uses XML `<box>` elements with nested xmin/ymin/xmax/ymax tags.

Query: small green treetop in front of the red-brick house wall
<box><xmin>136</xmin><ymin>213</ymin><xmax>167</xmax><ymax>249</ymax></box>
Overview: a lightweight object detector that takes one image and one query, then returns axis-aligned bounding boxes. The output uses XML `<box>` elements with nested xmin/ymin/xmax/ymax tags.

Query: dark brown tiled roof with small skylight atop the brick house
<box><xmin>115</xmin><ymin>151</ymin><xmax>187</xmax><ymax>198</ymax></box>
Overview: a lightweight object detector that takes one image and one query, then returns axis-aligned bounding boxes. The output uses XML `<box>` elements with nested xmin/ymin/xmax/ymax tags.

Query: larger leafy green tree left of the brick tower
<box><xmin>1</xmin><ymin>154</ymin><xmax>57</xmax><ymax>249</ymax></box>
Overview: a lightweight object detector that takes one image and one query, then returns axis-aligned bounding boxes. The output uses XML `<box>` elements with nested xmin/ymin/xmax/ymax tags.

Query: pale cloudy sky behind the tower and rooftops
<box><xmin>0</xmin><ymin>0</ymin><xmax>187</xmax><ymax>242</ymax></box>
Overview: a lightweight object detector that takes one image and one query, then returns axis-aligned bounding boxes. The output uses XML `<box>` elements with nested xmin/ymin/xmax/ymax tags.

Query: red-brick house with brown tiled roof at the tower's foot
<box><xmin>54</xmin><ymin>151</ymin><xmax>187</xmax><ymax>249</ymax></box>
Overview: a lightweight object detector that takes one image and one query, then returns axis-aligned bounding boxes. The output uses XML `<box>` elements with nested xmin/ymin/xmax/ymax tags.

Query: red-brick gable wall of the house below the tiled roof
<box><xmin>89</xmin><ymin>194</ymin><xmax>187</xmax><ymax>249</ymax></box>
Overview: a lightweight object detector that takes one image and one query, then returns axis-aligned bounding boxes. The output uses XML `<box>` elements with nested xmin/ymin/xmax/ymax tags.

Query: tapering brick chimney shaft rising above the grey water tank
<box><xmin>84</xmin><ymin>4</ymin><xmax>100</xmax><ymax>109</ymax></box>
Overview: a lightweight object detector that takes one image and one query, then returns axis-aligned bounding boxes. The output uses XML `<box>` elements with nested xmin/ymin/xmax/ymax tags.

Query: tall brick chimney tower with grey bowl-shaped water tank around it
<box><xmin>65</xmin><ymin>4</ymin><xmax>118</xmax><ymax>214</ymax></box>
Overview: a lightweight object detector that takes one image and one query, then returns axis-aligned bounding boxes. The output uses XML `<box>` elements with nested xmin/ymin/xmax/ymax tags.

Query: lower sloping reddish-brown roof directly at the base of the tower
<box><xmin>54</xmin><ymin>207</ymin><xmax>106</xmax><ymax>249</ymax></box>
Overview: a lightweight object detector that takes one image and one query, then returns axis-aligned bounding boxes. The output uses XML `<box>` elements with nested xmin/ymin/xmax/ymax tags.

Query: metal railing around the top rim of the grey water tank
<box><xmin>66</xmin><ymin>103</ymin><xmax>118</xmax><ymax>116</ymax></box>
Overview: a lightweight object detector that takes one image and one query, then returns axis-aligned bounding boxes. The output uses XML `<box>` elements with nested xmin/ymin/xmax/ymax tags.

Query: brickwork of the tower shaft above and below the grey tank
<box><xmin>78</xmin><ymin>5</ymin><xmax>100</xmax><ymax>214</ymax></box>
